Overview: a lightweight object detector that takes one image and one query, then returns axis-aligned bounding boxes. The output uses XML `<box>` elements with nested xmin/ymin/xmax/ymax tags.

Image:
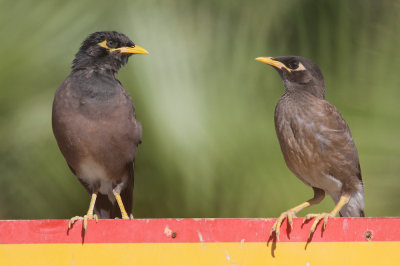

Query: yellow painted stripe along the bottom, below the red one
<box><xmin>0</xmin><ymin>242</ymin><xmax>400</xmax><ymax>266</ymax></box>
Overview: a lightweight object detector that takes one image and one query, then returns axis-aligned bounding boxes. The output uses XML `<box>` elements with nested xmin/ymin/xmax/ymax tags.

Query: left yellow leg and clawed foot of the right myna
<box><xmin>270</xmin><ymin>187</ymin><xmax>325</xmax><ymax>240</ymax></box>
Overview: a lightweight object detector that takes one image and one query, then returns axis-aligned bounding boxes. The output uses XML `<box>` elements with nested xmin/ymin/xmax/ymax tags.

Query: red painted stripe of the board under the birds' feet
<box><xmin>0</xmin><ymin>218</ymin><xmax>400</xmax><ymax>244</ymax></box>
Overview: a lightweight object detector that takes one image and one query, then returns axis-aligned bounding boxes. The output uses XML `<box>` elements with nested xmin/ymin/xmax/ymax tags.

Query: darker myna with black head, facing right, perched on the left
<box><xmin>52</xmin><ymin>31</ymin><xmax>148</xmax><ymax>230</ymax></box>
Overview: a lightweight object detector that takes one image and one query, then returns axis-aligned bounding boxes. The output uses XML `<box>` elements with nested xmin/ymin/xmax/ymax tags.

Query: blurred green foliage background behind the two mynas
<box><xmin>0</xmin><ymin>0</ymin><xmax>400</xmax><ymax>219</ymax></box>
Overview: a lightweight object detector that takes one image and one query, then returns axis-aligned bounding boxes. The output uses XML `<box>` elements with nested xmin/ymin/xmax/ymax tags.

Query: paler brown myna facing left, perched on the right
<box><xmin>256</xmin><ymin>56</ymin><xmax>364</xmax><ymax>239</ymax></box>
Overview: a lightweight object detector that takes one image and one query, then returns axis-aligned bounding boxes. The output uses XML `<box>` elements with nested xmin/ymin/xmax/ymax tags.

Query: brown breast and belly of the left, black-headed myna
<box><xmin>53</xmin><ymin>74</ymin><xmax>141</xmax><ymax>184</ymax></box>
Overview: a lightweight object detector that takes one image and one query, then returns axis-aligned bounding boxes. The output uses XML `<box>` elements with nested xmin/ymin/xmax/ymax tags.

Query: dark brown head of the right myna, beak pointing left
<box><xmin>256</xmin><ymin>56</ymin><xmax>325</xmax><ymax>98</ymax></box>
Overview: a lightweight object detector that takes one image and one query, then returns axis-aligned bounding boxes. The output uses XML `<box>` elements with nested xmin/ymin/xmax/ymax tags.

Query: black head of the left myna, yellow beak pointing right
<box><xmin>72</xmin><ymin>31</ymin><xmax>148</xmax><ymax>72</ymax></box>
